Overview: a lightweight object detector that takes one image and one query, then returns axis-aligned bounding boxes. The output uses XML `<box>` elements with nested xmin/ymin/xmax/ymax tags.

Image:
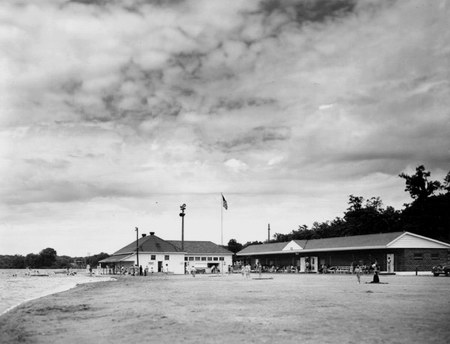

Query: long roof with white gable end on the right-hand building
<box><xmin>237</xmin><ymin>232</ymin><xmax>450</xmax><ymax>256</ymax></box>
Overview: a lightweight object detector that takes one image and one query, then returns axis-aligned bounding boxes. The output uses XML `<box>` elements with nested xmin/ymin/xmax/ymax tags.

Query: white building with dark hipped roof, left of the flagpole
<box><xmin>100</xmin><ymin>232</ymin><xmax>233</xmax><ymax>274</ymax></box>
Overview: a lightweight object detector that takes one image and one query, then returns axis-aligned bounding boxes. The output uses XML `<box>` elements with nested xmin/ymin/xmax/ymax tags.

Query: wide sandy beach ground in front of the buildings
<box><xmin>0</xmin><ymin>274</ymin><xmax>450</xmax><ymax>344</ymax></box>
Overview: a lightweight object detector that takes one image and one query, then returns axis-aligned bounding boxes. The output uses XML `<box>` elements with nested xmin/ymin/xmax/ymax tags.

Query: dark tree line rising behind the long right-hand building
<box><xmin>228</xmin><ymin>165</ymin><xmax>450</xmax><ymax>252</ymax></box>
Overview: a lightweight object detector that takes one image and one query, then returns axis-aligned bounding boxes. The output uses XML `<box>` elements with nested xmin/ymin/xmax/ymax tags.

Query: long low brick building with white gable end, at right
<box><xmin>236</xmin><ymin>232</ymin><xmax>450</xmax><ymax>274</ymax></box>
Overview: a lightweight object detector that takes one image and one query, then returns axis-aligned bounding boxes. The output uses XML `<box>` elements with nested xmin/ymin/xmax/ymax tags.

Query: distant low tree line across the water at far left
<box><xmin>0</xmin><ymin>247</ymin><xmax>109</xmax><ymax>269</ymax></box>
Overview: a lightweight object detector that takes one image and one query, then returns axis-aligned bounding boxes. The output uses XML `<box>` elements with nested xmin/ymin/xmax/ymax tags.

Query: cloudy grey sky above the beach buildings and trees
<box><xmin>0</xmin><ymin>0</ymin><xmax>450</xmax><ymax>256</ymax></box>
